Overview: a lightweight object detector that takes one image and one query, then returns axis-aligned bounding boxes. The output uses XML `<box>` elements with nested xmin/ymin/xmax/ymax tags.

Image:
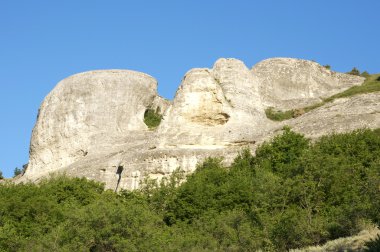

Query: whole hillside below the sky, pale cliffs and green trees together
<box><xmin>0</xmin><ymin>58</ymin><xmax>380</xmax><ymax>251</ymax></box>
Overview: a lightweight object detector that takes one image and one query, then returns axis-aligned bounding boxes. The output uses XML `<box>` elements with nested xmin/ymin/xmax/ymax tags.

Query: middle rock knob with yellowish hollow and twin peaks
<box><xmin>157</xmin><ymin>59</ymin><xmax>271</xmax><ymax>148</ymax></box>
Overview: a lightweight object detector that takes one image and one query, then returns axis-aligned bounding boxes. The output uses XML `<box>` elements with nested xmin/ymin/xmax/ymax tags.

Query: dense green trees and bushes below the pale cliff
<box><xmin>0</xmin><ymin>128</ymin><xmax>380</xmax><ymax>251</ymax></box>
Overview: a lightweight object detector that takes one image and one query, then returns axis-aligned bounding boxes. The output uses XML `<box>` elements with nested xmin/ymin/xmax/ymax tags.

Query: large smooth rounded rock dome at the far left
<box><xmin>25</xmin><ymin>70</ymin><xmax>157</xmax><ymax>181</ymax></box>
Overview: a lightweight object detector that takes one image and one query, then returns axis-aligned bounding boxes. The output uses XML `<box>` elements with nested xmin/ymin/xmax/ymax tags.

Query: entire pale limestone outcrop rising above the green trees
<box><xmin>17</xmin><ymin>59</ymin><xmax>380</xmax><ymax>189</ymax></box>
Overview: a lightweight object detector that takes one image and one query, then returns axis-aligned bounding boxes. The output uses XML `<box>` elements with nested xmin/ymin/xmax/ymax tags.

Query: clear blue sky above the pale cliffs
<box><xmin>0</xmin><ymin>0</ymin><xmax>380</xmax><ymax>177</ymax></box>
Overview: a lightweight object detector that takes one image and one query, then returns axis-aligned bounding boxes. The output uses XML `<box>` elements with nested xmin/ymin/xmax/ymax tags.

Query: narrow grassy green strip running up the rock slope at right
<box><xmin>265</xmin><ymin>72</ymin><xmax>380</xmax><ymax>121</ymax></box>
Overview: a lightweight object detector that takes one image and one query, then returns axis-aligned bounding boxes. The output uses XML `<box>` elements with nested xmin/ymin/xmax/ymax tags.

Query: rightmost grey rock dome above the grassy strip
<box><xmin>252</xmin><ymin>58</ymin><xmax>365</xmax><ymax>110</ymax></box>
